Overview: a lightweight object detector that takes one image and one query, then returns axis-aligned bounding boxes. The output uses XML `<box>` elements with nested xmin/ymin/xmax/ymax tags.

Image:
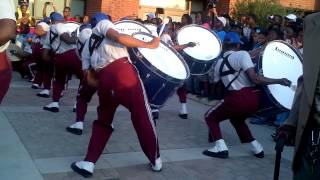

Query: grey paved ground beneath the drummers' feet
<box><xmin>0</xmin><ymin>74</ymin><xmax>292</xmax><ymax>180</ymax></box>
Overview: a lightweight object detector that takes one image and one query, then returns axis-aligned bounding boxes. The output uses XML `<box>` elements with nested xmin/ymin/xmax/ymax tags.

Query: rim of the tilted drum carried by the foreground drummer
<box><xmin>130</xmin><ymin>32</ymin><xmax>190</xmax><ymax>83</ymax></box>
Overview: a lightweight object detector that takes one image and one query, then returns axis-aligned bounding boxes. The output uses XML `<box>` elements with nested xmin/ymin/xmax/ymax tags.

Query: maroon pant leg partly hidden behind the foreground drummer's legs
<box><xmin>76</xmin><ymin>74</ymin><xmax>97</xmax><ymax>122</ymax></box>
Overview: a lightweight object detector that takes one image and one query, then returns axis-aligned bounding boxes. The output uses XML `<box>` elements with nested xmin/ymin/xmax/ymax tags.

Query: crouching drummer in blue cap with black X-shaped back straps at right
<box><xmin>203</xmin><ymin>32</ymin><xmax>291</xmax><ymax>158</ymax></box>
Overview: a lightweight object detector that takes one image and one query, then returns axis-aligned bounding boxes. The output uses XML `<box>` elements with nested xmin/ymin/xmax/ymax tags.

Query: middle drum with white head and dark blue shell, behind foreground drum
<box><xmin>177</xmin><ymin>24</ymin><xmax>222</xmax><ymax>75</ymax></box>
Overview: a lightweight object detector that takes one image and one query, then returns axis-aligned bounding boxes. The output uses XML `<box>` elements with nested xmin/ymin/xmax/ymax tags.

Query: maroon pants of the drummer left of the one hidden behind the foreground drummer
<box><xmin>52</xmin><ymin>49</ymin><xmax>83</xmax><ymax>102</ymax></box>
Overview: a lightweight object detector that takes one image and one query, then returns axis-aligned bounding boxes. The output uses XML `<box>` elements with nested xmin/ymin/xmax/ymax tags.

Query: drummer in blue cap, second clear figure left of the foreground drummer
<box><xmin>43</xmin><ymin>12</ymin><xmax>83</xmax><ymax>112</ymax></box>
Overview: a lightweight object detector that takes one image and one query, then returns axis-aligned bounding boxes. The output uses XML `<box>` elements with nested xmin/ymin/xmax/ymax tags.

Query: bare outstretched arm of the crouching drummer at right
<box><xmin>246</xmin><ymin>68</ymin><xmax>291</xmax><ymax>86</ymax></box>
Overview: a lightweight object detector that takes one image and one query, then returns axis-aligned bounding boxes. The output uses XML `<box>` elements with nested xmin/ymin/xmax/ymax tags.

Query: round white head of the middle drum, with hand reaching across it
<box><xmin>177</xmin><ymin>25</ymin><xmax>222</xmax><ymax>61</ymax></box>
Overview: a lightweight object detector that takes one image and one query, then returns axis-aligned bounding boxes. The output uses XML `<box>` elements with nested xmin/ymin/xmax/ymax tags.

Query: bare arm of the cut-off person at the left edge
<box><xmin>0</xmin><ymin>19</ymin><xmax>16</xmax><ymax>46</ymax></box>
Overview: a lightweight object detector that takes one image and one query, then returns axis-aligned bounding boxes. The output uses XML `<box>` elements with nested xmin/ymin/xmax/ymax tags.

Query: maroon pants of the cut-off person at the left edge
<box><xmin>0</xmin><ymin>52</ymin><xmax>12</xmax><ymax>104</ymax></box>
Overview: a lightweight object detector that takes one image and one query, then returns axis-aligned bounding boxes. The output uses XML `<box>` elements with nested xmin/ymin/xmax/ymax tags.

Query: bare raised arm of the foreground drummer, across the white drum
<box><xmin>106</xmin><ymin>28</ymin><xmax>160</xmax><ymax>49</ymax></box>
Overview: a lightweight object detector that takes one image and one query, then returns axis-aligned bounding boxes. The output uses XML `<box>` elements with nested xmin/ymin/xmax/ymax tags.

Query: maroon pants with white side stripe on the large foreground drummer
<box><xmin>85</xmin><ymin>58</ymin><xmax>160</xmax><ymax>164</ymax></box>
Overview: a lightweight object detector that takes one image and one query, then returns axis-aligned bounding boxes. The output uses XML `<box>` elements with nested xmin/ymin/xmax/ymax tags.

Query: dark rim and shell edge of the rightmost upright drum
<box><xmin>257</xmin><ymin>40</ymin><xmax>303</xmax><ymax>110</ymax></box>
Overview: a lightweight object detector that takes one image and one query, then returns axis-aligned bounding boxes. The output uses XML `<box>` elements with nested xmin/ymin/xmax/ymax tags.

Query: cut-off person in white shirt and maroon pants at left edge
<box><xmin>0</xmin><ymin>0</ymin><xmax>16</xmax><ymax>104</ymax></box>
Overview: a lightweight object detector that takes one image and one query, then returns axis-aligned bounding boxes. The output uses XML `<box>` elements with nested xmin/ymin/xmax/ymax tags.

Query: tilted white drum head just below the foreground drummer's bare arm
<box><xmin>133</xmin><ymin>34</ymin><xmax>189</xmax><ymax>80</ymax></box>
